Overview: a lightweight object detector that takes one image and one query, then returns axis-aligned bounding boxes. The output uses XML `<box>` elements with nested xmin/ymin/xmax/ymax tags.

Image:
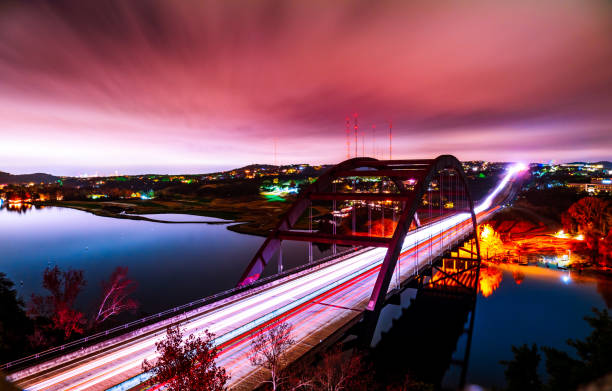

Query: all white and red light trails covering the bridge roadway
<box><xmin>9</xmin><ymin>168</ymin><xmax>520</xmax><ymax>391</ymax></box>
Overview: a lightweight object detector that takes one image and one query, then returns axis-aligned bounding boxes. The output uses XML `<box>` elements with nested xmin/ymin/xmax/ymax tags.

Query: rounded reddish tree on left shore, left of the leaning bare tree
<box><xmin>28</xmin><ymin>266</ymin><xmax>86</xmax><ymax>338</ymax></box>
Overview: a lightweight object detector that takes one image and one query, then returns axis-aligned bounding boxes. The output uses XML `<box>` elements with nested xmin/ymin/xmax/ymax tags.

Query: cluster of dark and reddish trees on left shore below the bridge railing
<box><xmin>0</xmin><ymin>266</ymin><xmax>138</xmax><ymax>362</ymax></box>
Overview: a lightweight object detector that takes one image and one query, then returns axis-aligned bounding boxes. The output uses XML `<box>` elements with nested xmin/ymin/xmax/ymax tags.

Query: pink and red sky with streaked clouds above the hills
<box><xmin>0</xmin><ymin>0</ymin><xmax>612</xmax><ymax>175</ymax></box>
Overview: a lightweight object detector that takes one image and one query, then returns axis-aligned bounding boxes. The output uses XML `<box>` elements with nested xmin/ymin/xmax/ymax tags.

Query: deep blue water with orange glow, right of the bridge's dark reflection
<box><xmin>467</xmin><ymin>265</ymin><xmax>612</xmax><ymax>385</ymax></box>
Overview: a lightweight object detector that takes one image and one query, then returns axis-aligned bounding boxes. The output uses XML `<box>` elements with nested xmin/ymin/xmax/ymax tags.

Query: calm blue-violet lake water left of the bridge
<box><xmin>0</xmin><ymin>207</ymin><xmax>322</xmax><ymax>313</ymax></box>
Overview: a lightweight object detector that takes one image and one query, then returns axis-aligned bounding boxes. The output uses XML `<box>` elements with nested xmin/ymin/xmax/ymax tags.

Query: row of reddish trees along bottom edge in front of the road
<box><xmin>142</xmin><ymin>322</ymin><xmax>434</xmax><ymax>391</ymax></box>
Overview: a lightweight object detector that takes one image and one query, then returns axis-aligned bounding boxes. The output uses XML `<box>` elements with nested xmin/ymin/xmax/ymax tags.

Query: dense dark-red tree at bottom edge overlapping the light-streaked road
<box><xmin>142</xmin><ymin>326</ymin><xmax>229</xmax><ymax>391</ymax></box>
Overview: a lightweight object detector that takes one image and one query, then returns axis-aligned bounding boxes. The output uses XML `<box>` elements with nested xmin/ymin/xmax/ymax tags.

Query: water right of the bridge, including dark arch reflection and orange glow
<box><xmin>374</xmin><ymin>263</ymin><xmax>612</xmax><ymax>389</ymax></box>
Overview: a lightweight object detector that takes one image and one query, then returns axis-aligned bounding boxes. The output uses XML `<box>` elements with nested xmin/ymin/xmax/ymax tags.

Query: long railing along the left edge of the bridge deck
<box><xmin>0</xmin><ymin>248</ymin><xmax>362</xmax><ymax>371</ymax></box>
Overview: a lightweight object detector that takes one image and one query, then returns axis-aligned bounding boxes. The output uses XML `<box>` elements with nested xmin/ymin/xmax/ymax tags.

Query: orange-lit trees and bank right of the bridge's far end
<box><xmin>484</xmin><ymin>188</ymin><xmax>612</xmax><ymax>268</ymax></box>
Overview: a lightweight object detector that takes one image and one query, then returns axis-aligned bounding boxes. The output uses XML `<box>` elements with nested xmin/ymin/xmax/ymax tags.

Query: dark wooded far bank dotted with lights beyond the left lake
<box><xmin>0</xmin><ymin>165</ymin><xmax>501</xmax><ymax>236</ymax></box>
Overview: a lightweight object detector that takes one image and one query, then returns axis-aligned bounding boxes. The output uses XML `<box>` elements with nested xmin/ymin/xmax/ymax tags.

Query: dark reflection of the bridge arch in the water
<box><xmin>373</xmin><ymin>260</ymin><xmax>478</xmax><ymax>389</ymax></box>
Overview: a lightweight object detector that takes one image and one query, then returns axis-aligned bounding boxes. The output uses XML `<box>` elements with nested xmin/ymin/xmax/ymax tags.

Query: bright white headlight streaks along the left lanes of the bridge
<box><xmin>26</xmin><ymin>165</ymin><xmax>523</xmax><ymax>391</ymax></box>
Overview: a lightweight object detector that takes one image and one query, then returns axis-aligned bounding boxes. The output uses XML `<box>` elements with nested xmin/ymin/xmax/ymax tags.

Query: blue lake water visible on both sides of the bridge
<box><xmin>0</xmin><ymin>208</ymin><xmax>612</xmax><ymax>386</ymax></box>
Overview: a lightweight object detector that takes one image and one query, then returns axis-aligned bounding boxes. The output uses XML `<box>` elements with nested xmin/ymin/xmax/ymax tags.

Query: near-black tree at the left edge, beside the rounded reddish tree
<box><xmin>0</xmin><ymin>272</ymin><xmax>32</xmax><ymax>362</ymax></box>
